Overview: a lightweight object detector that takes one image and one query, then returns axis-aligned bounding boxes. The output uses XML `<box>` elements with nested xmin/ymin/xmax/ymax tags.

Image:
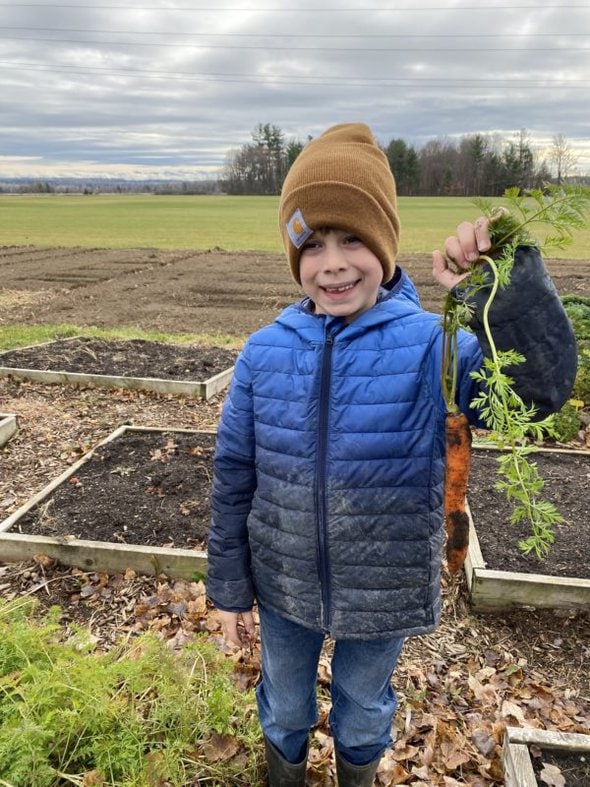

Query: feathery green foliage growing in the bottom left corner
<box><xmin>0</xmin><ymin>603</ymin><xmax>260</xmax><ymax>787</ymax></box>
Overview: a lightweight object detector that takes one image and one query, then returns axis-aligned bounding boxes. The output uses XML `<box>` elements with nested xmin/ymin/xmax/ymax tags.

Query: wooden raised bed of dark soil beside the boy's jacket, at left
<box><xmin>0</xmin><ymin>426</ymin><xmax>215</xmax><ymax>579</ymax></box>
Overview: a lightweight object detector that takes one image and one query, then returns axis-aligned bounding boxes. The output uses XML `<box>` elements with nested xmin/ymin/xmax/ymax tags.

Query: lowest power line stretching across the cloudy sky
<box><xmin>0</xmin><ymin>60</ymin><xmax>590</xmax><ymax>90</ymax></box>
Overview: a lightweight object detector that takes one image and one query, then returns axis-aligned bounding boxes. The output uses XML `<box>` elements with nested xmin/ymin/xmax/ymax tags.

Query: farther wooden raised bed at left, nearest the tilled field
<box><xmin>0</xmin><ymin>336</ymin><xmax>237</xmax><ymax>399</ymax></box>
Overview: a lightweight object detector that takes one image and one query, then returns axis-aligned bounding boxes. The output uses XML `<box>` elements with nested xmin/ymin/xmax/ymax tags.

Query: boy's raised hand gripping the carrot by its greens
<box><xmin>432</xmin><ymin>216</ymin><xmax>492</xmax><ymax>290</ymax></box>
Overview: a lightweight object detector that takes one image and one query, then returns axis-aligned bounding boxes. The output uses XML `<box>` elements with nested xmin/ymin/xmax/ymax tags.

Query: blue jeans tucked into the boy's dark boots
<box><xmin>256</xmin><ymin>605</ymin><xmax>404</xmax><ymax>765</ymax></box>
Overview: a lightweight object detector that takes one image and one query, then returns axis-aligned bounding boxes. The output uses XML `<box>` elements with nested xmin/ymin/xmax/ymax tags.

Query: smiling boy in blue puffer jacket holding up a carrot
<box><xmin>207</xmin><ymin>124</ymin><xmax>576</xmax><ymax>787</ymax></box>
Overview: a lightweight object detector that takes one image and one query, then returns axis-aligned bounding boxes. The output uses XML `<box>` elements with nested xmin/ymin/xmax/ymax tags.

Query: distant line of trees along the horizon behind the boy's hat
<box><xmin>0</xmin><ymin>123</ymin><xmax>590</xmax><ymax>197</ymax></box>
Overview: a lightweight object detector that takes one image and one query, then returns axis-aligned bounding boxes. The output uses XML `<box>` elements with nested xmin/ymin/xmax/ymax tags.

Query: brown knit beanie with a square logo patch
<box><xmin>279</xmin><ymin>123</ymin><xmax>400</xmax><ymax>284</ymax></box>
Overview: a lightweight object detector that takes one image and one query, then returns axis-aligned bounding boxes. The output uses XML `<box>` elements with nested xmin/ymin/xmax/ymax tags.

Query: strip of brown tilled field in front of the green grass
<box><xmin>0</xmin><ymin>247</ymin><xmax>590</xmax><ymax>337</ymax></box>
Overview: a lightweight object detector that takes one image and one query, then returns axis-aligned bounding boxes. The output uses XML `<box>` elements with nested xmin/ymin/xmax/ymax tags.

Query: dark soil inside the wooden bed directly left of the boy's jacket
<box><xmin>16</xmin><ymin>431</ymin><xmax>215</xmax><ymax>549</ymax></box>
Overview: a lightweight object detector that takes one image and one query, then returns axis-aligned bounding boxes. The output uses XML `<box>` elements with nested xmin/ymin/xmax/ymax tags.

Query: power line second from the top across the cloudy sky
<box><xmin>0</xmin><ymin>35</ymin><xmax>590</xmax><ymax>54</ymax></box>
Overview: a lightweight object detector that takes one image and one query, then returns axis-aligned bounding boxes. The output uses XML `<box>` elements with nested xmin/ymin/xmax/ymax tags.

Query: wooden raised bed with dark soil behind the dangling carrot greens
<box><xmin>465</xmin><ymin>448</ymin><xmax>590</xmax><ymax>611</ymax></box>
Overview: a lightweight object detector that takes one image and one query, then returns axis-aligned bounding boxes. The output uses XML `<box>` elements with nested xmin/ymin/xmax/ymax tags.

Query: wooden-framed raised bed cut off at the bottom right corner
<box><xmin>502</xmin><ymin>727</ymin><xmax>590</xmax><ymax>787</ymax></box>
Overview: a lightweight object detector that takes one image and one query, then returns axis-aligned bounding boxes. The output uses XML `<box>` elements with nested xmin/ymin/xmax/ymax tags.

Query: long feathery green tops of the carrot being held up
<box><xmin>441</xmin><ymin>186</ymin><xmax>590</xmax><ymax>557</ymax></box>
